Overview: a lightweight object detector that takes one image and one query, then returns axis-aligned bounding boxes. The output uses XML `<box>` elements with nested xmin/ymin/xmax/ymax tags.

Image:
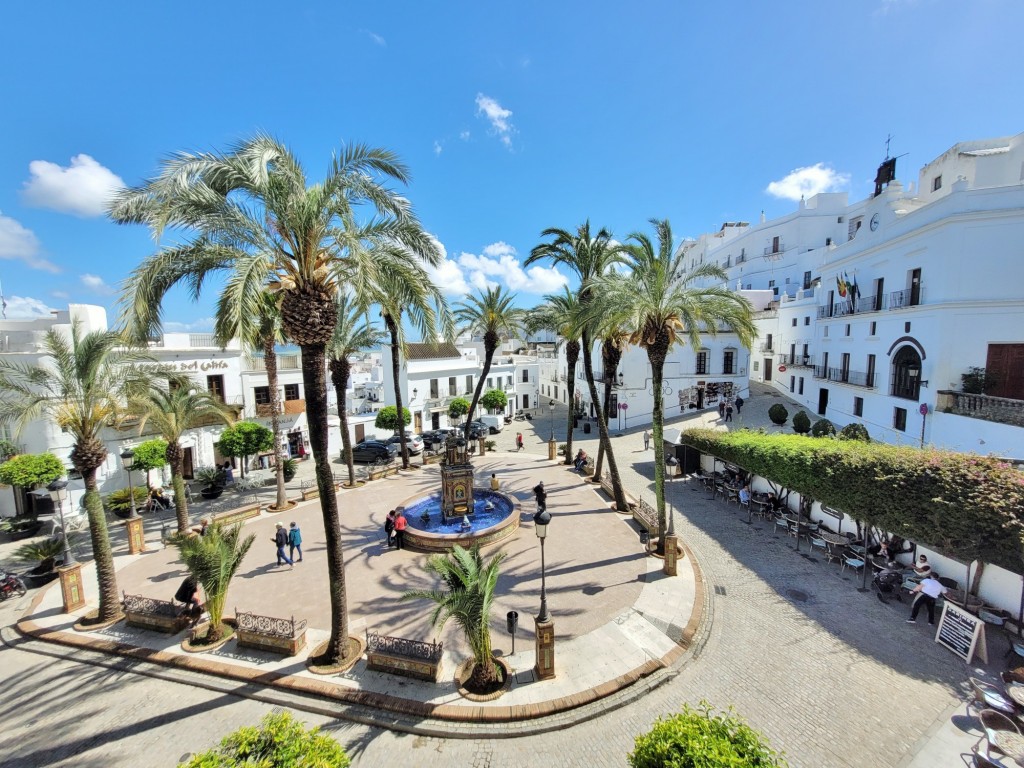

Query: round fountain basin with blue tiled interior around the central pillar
<box><xmin>398</xmin><ymin>488</ymin><xmax>519</xmax><ymax>552</ymax></box>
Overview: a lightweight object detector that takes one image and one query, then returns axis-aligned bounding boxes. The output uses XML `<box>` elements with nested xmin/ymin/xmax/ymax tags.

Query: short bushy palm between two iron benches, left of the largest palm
<box><xmin>171</xmin><ymin>523</ymin><xmax>256</xmax><ymax>642</ymax></box>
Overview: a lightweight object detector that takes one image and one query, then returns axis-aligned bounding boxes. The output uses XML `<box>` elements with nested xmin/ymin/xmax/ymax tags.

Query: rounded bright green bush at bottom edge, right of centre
<box><xmin>629</xmin><ymin>701</ymin><xmax>786</xmax><ymax>768</ymax></box>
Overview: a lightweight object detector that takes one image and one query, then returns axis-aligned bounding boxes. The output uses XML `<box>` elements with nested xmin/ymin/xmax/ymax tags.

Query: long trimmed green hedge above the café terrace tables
<box><xmin>682</xmin><ymin>429</ymin><xmax>1024</xmax><ymax>572</ymax></box>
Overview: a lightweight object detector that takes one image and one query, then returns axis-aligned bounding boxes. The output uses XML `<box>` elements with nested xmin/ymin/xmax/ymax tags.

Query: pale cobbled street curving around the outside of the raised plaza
<box><xmin>0</xmin><ymin>390</ymin><xmax>1002</xmax><ymax>768</ymax></box>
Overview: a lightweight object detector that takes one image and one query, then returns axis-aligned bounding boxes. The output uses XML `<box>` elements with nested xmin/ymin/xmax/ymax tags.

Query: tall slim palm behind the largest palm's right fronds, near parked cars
<box><xmin>368</xmin><ymin>264</ymin><xmax>455</xmax><ymax>469</ymax></box>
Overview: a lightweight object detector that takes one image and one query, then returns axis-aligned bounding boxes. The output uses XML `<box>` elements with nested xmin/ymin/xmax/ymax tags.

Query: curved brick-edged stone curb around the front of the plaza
<box><xmin>4</xmin><ymin>544</ymin><xmax>710</xmax><ymax>738</ymax></box>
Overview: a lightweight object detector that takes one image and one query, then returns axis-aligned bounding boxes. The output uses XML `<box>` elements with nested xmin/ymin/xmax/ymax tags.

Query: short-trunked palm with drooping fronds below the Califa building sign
<box><xmin>126</xmin><ymin>376</ymin><xmax>234</xmax><ymax>534</ymax></box>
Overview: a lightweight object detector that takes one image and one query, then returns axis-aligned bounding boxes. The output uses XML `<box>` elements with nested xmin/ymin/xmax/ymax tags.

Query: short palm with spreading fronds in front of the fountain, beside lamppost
<box><xmin>401</xmin><ymin>544</ymin><xmax>505</xmax><ymax>690</ymax></box>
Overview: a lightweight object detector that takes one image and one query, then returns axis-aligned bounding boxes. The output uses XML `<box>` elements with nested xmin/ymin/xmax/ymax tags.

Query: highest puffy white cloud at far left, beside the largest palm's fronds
<box><xmin>22</xmin><ymin>155</ymin><xmax>125</xmax><ymax>217</ymax></box>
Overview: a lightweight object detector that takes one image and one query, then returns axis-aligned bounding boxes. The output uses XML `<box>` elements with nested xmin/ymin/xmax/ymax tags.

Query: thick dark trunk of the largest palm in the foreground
<box><xmin>300</xmin><ymin>343</ymin><xmax>348</xmax><ymax>665</ymax></box>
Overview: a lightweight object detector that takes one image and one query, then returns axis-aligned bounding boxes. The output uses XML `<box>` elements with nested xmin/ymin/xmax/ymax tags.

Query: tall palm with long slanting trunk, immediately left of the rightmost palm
<box><xmin>526</xmin><ymin>221</ymin><xmax>629</xmax><ymax>512</ymax></box>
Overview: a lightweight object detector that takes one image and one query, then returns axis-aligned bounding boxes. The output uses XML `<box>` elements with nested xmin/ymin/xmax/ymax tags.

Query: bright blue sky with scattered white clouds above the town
<box><xmin>0</xmin><ymin>0</ymin><xmax>1024</xmax><ymax>330</ymax></box>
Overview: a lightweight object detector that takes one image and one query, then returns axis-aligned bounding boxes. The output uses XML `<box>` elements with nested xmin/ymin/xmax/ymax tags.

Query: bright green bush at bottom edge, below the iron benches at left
<box><xmin>179</xmin><ymin>712</ymin><xmax>350</xmax><ymax>768</ymax></box>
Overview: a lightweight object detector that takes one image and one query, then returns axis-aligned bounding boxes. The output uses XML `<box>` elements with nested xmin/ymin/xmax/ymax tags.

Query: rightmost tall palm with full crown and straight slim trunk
<box><xmin>595</xmin><ymin>219</ymin><xmax>757</xmax><ymax>552</ymax></box>
